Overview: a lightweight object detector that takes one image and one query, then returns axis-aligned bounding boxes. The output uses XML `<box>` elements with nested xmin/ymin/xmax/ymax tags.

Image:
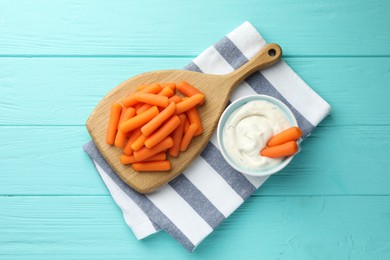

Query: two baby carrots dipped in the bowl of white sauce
<box><xmin>260</xmin><ymin>126</ymin><xmax>302</xmax><ymax>158</ymax></box>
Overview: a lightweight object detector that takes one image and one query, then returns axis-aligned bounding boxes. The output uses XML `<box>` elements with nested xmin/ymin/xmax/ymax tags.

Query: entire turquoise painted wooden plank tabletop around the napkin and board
<box><xmin>0</xmin><ymin>0</ymin><xmax>390</xmax><ymax>259</ymax></box>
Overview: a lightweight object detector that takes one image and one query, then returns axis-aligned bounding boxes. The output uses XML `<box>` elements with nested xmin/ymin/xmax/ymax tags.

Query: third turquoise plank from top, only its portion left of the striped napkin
<box><xmin>0</xmin><ymin>126</ymin><xmax>109</xmax><ymax>195</ymax></box>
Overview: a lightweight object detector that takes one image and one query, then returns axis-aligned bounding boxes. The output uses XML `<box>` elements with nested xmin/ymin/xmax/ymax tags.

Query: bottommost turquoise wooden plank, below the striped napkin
<box><xmin>0</xmin><ymin>196</ymin><xmax>390</xmax><ymax>259</ymax></box>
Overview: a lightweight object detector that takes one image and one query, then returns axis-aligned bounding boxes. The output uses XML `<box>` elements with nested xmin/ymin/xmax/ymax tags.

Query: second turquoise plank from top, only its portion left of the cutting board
<box><xmin>0</xmin><ymin>58</ymin><xmax>189</xmax><ymax>125</ymax></box>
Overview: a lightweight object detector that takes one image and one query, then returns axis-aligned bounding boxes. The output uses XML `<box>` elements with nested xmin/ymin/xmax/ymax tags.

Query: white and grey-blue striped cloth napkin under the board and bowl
<box><xmin>84</xmin><ymin>22</ymin><xmax>330</xmax><ymax>252</ymax></box>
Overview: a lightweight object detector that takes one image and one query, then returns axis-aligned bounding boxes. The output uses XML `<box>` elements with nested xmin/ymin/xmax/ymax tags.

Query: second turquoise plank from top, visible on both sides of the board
<box><xmin>0</xmin><ymin>58</ymin><xmax>390</xmax><ymax>126</ymax></box>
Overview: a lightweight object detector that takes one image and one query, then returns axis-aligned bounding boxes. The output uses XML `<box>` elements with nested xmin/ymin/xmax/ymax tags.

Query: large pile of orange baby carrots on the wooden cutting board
<box><xmin>106</xmin><ymin>81</ymin><xmax>205</xmax><ymax>171</ymax></box>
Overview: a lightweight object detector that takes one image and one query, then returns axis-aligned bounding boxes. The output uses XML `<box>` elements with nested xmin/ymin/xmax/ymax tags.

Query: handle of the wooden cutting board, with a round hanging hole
<box><xmin>226</xmin><ymin>43</ymin><xmax>282</xmax><ymax>86</ymax></box>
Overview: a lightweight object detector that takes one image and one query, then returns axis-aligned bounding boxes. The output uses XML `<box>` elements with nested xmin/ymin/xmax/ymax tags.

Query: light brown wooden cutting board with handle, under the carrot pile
<box><xmin>86</xmin><ymin>44</ymin><xmax>282</xmax><ymax>194</ymax></box>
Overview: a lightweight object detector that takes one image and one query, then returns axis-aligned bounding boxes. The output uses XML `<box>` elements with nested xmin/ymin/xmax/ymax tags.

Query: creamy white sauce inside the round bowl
<box><xmin>222</xmin><ymin>100</ymin><xmax>291</xmax><ymax>170</ymax></box>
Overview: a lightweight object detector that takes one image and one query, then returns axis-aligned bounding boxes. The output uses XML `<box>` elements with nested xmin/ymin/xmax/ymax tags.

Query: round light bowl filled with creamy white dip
<box><xmin>217</xmin><ymin>95</ymin><xmax>298</xmax><ymax>176</ymax></box>
